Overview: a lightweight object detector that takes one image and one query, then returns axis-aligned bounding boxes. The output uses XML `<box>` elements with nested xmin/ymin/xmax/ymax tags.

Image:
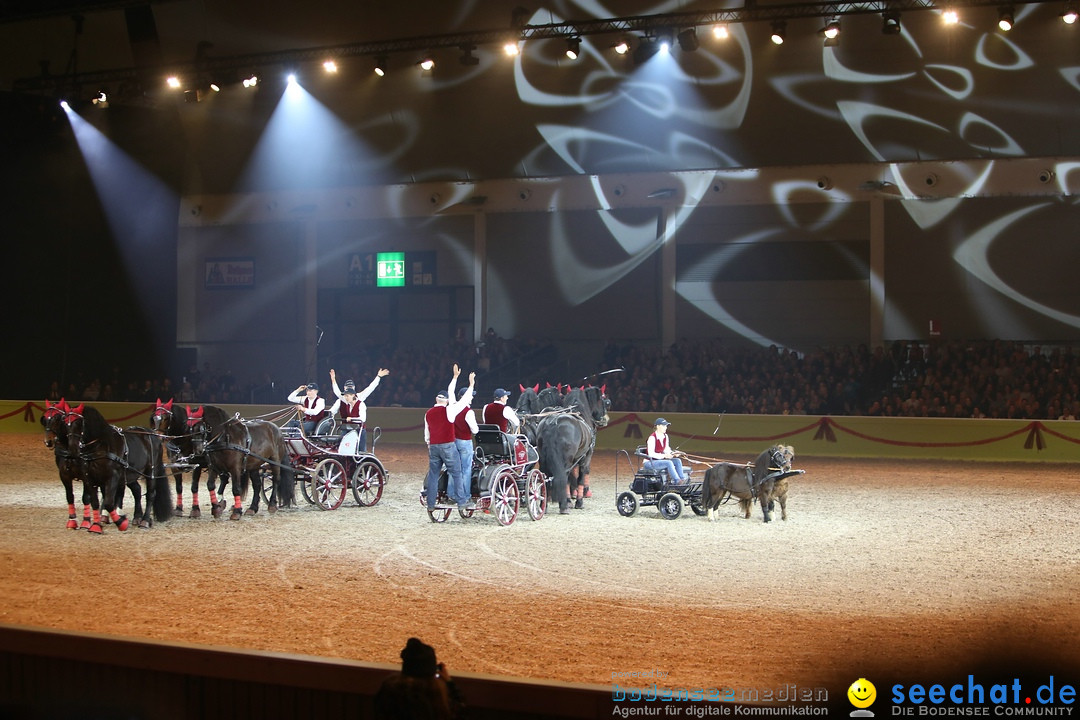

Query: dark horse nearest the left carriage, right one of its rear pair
<box><xmin>192</xmin><ymin>412</ymin><xmax>296</xmax><ymax>520</ymax></box>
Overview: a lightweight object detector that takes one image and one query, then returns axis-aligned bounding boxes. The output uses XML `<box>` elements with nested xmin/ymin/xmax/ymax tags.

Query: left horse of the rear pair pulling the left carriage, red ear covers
<box><xmin>150</xmin><ymin>398</ymin><xmax>229</xmax><ymax>517</ymax></box>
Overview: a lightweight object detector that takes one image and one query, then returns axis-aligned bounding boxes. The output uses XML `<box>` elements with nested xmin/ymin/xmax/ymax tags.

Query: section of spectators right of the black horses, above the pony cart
<box><xmin>604</xmin><ymin>340</ymin><xmax>1080</xmax><ymax>420</ymax></box>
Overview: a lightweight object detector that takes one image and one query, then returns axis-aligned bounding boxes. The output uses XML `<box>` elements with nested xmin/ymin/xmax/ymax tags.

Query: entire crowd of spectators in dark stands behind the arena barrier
<box><xmin>49</xmin><ymin>338</ymin><xmax>1080</xmax><ymax>420</ymax></box>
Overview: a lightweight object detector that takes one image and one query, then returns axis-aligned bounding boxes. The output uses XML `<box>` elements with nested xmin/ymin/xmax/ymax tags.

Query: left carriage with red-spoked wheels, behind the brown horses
<box><xmin>281</xmin><ymin>418</ymin><xmax>389</xmax><ymax>510</ymax></box>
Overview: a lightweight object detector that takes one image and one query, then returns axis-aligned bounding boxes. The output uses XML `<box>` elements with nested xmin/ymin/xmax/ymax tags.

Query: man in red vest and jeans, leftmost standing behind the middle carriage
<box><xmin>423</xmin><ymin>363</ymin><xmax>476</xmax><ymax>521</ymax></box>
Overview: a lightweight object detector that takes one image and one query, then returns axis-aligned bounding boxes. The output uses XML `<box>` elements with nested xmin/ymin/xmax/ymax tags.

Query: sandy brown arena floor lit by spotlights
<box><xmin>0</xmin><ymin>435</ymin><xmax>1080</xmax><ymax>692</ymax></box>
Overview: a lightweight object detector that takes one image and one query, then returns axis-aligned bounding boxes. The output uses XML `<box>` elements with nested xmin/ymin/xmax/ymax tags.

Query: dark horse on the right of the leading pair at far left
<box><xmin>64</xmin><ymin>404</ymin><xmax>173</xmax><ymax>534</ymax></box>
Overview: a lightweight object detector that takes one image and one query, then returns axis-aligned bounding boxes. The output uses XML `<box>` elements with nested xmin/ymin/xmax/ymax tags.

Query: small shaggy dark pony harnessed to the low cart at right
<box><xmin>701</xmin><ymin>445</ymin><xmax>801</xmax><ymax>522</ymax></box>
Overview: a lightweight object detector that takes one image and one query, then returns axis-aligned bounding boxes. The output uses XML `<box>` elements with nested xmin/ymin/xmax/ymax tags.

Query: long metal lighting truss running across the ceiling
<box><xmin>13</xmin><ymin>0</ymin><xmax>1066</xmax><ymax>93</ymax></box>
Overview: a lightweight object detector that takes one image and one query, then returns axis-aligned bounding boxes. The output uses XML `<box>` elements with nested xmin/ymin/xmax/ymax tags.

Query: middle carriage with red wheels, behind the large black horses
<box><xmin>420</xmin><ymin>424</ymin><xmax>551</xmax><ymax>526</ymax></box>
